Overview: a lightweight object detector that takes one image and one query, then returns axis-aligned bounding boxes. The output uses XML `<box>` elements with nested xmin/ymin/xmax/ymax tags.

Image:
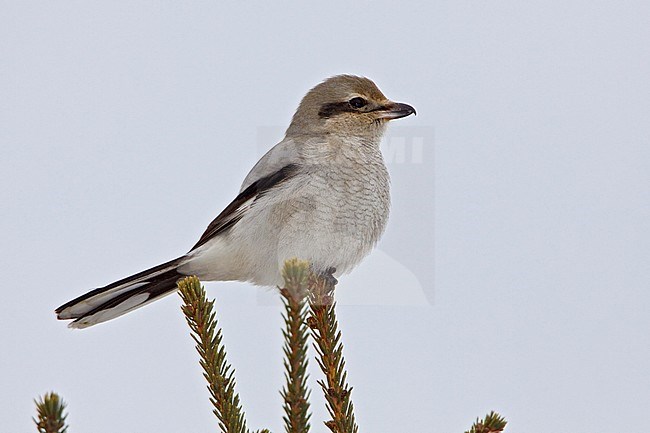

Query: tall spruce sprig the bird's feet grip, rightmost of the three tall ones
<box><xmin>307</xmin><ymin>273</ymin><xmax>358</xmax><ymax>433</ymax></box>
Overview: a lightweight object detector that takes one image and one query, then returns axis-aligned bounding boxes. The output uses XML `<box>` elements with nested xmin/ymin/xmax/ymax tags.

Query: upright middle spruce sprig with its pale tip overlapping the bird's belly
<box><xmin>280</xmin><ymin>259</ymin><xmax>311</xmax><ymax>433</ymax></box>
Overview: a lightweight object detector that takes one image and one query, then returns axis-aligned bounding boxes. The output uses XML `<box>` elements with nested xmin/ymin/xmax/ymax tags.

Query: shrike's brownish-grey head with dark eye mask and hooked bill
<box><xmin>287</xmin><ymin>75</ymin><xmax>415</xmax><ymax>139</ymax></box>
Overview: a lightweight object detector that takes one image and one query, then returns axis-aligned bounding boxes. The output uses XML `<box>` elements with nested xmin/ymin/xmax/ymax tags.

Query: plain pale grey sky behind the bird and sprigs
<box><xmin>0</xmin><ymin>1</ymin><xmax>650</xmax><ymax>433</ymax></box>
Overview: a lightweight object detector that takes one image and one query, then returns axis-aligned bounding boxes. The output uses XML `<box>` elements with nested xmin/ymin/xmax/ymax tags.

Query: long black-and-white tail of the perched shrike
<box><xmin>55</xmin><ymin>258</ymin><xmax>185</xmax><ymax>328</ymax></box>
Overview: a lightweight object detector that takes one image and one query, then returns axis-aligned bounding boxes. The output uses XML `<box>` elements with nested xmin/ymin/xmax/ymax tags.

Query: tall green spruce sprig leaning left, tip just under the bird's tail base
<box><xmin>178</xmin><ymin>277</ymin><xmax>248</xmax><ymax>433</ymax></box>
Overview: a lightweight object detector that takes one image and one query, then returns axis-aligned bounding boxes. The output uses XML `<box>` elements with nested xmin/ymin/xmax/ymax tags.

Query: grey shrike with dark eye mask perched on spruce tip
<box><xmin>55</xmin><ymin>75</ymin><xmax>416</xmax><ymax>329</ymax></box>
